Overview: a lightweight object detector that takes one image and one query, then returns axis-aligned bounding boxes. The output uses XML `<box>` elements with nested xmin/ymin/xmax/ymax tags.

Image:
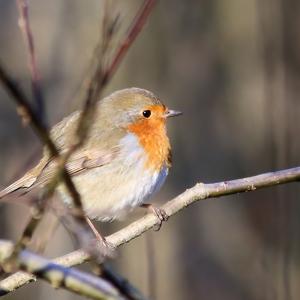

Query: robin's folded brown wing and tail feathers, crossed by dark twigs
<box><xmin>0</xmin><ymin>147</ymin><xmax>118</xmax><ymax>199</ymax></box>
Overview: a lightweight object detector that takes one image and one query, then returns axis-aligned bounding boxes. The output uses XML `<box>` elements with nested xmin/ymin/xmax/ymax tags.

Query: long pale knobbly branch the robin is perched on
<box><xmin>1</xmin><ymin>167</ymin><xmax>300</xmax><ymax>291</ymax></box>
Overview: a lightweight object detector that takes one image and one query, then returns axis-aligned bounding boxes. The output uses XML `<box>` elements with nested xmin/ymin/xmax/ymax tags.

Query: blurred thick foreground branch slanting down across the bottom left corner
<box><xmin>0</xmin><ymin>241</ymin><xmax>124</xmax><ymax>299</ymax></box>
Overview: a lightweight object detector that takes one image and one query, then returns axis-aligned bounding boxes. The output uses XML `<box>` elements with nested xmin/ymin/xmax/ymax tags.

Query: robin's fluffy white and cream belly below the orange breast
<box><xmin>57</xmin><ymin>134</ymin><xmax>168</xmax><ymax>221</ymax></box>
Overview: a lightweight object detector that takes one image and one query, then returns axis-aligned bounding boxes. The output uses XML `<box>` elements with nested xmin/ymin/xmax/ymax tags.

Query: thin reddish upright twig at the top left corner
<box><xmin>17</xmin><ymin>0</ymin><xmax>45</xmax><ymax>122</ymax></box>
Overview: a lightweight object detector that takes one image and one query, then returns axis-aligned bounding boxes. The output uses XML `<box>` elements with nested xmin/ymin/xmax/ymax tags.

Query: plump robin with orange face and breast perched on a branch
<box><xmin>0</xmin><ymin>87</ymin><xmax>182</xmax><ymax>251</ymax></box>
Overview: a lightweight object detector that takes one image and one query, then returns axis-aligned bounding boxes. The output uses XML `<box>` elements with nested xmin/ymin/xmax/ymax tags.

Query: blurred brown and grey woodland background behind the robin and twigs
<box><xmin>0</xmin><ymin>0</ymin><xmax>300</xmax><ymax>300</ymax></box>
